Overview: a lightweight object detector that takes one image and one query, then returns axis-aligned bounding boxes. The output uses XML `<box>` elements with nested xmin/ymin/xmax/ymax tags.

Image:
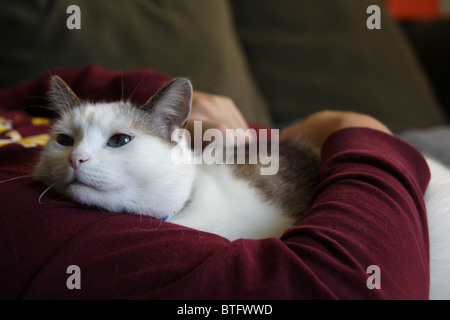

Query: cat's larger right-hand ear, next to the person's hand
<box><xmin>142</xmin><ymin>78</ymin><xmax>193</xmax><ymax>138</ymax></box>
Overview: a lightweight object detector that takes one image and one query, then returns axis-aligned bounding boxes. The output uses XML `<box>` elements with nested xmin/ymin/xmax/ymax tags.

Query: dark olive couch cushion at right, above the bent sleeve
<box><xmin>232</xmin><ymin>0</ymin><xmax>445</xmax><ymax>128</ymax></box>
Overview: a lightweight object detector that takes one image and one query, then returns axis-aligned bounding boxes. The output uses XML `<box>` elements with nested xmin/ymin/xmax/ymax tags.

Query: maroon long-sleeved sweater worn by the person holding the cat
<box><xmin>0</xmin><ymin>66</ymin><xmax>430</xmax><ymax>299</ymax></box>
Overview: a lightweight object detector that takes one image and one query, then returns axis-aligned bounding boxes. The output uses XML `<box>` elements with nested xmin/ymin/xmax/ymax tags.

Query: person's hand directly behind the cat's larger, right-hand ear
<box><xmin>186</xmin><ymin>91</ymin><xmax>248</xmax><ymax>147</ymax></box>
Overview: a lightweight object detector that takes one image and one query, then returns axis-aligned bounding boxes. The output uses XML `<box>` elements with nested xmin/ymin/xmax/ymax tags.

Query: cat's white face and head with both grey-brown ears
<box><xmin>35</xmin><ymin>76</ymin><xmax>194</xmax><ymax>218</ymax></box>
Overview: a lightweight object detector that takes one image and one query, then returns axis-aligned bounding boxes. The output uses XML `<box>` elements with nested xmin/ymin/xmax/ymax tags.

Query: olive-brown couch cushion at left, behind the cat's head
<box><xmin>0</xmin><ymin>0</ymin><xmax>270</xmax><ymax>125</ymax></box>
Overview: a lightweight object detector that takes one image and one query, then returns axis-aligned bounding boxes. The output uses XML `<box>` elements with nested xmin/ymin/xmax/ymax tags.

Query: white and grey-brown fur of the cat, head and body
<box><xmin>35</xmin><ymin>77</ymin><xmax>450</xmax><ymax>299</ymax></box>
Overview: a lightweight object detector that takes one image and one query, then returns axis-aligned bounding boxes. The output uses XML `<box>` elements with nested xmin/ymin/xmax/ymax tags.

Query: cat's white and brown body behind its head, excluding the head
<box><xmin>167</xmin><ymin>138</ymin><xmax>318</xmax><ymax>240</ymax></box>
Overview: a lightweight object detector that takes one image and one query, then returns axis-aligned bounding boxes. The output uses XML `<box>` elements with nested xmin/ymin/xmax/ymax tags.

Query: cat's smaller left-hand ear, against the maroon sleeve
<box><xmin>49</xmin><ymin>76</ymin><xmax>81</xmax><ymax>114</ymax></box>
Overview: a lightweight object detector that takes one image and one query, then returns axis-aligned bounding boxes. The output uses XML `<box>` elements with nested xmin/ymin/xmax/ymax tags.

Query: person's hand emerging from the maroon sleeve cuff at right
<box><xmin>280</xmin><ymin>111</ymin><xmax>392</xmax><ymax>152</ymax></box>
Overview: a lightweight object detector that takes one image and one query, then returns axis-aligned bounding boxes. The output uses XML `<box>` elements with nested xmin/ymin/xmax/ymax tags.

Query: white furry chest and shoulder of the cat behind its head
<box><xmin>167</xmin><ymin>160</ymin><xmax>295</xmax><ymax>240</ymax></box>
